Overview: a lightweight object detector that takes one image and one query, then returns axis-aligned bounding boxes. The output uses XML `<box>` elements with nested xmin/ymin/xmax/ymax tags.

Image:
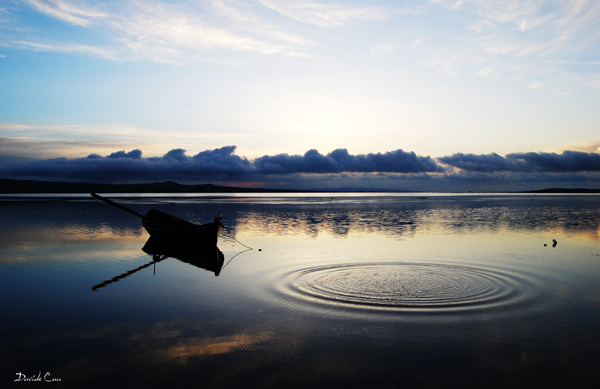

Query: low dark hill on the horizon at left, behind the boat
<box><xmin>0</xmin><ymin>178</ymin><xmax>308</xmax><ymax>194</ymax></box>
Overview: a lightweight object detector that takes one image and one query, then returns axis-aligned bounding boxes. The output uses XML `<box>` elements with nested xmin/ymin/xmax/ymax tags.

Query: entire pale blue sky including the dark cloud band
<box><xmin>0</xmin><ymin>0</ymin><xmax>600</xmax><ymax>191</ymax></box>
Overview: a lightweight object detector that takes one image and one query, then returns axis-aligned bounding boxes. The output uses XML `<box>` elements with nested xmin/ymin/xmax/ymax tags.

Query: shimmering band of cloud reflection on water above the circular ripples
<box><xmin>233</xmin><ymin>205</ymin><xmax>600</xmax><ymax>240</ymax></box>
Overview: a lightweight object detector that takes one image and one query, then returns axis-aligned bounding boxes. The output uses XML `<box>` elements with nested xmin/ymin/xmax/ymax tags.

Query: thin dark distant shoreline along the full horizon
<box><xmin>0</xmin><ymin>178</ymin><xmax>600</xmax><ymax>194</ymax></box>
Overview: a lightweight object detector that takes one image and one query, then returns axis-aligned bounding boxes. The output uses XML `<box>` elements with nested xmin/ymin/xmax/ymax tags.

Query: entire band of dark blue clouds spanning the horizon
<box><xmin>0</xmin><ymin>146</ymin><xmax>600</xmax><ymax>191</ymax></box>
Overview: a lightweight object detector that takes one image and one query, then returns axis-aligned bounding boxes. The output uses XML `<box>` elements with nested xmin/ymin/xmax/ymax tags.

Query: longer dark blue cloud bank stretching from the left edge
<box><xmin>0</xmin><ymin>146</ymin><xmax>444</xmax><ymax>182</ymax></box>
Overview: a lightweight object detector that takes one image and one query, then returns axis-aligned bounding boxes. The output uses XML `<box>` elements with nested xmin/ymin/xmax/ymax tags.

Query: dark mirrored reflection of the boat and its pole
<box><xmin>92</xmin><ymin>236</ymin><xmax>225</xmax><ymax>291</ymax></box>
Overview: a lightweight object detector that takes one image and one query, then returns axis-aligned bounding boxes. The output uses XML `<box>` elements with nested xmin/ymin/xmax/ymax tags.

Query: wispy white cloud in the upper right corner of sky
<box><xmin>423</xmin><ymin>0</ymin><xmax>600</xmax><ymax>89</ymax></box>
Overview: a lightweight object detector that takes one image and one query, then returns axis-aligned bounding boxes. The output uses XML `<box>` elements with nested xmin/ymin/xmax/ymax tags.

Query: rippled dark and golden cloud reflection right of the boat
<box><xmin>226</xmin><ymin>196</ymin><xmax>600</xmax><ymax>240</ymax></box>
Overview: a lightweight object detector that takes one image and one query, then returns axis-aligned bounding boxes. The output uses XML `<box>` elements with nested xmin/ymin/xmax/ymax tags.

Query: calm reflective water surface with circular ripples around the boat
<box><xmin>0</xmin><ymin>194</ymin><xmax>600</xmax><ymax>388</ymax></box>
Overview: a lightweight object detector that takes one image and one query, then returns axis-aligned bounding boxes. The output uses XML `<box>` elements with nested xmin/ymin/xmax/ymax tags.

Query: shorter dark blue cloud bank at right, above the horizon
<box><xmin>439</xmin><ymin>151</ymin><xmax>600</xmax><ymax>173</ymax></box>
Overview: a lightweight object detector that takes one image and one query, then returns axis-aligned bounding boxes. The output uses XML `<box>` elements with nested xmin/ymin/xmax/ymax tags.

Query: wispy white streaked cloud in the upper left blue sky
<box><xmin>5</xmin><ymin>0</ymin><xmax>418</xmax><ymax>63</ymax></box>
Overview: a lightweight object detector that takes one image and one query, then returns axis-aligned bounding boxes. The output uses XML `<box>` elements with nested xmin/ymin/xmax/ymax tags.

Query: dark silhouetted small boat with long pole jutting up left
<box><xmin>91</xmin><ymin>193</ymin><xmax>223</xmax><ymax>247</ymax></box>
